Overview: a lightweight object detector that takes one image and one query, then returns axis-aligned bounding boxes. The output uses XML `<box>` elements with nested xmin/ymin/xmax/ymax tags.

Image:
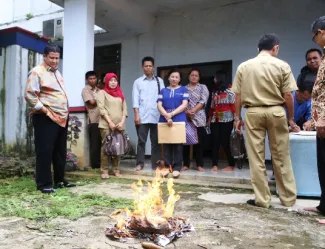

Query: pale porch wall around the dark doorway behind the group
<box><xmin>115</xmin><ymin>0</ymin><xmax>325</xmax><ymax>158</ymax></box>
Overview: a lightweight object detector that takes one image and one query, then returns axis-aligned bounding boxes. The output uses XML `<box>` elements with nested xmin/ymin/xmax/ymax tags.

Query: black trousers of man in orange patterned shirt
<box><xmin>33</xmin><ymin>114</ymin><xmax>67</xmax><ymax>189</ymax></box>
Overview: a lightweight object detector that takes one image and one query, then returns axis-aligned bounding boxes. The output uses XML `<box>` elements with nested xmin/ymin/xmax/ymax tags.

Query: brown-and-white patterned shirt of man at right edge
<box><xmin>312</xmin><ymin>51</ymin><xmax>325</xmax><ymax>127</ymax></box>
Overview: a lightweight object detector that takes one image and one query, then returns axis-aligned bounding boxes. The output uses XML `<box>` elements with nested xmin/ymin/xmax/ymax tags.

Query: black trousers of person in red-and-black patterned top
<box><xmin>210</xmin><ymin>121</ymin><xmax>236</xmax><ymax>166</ymax></box>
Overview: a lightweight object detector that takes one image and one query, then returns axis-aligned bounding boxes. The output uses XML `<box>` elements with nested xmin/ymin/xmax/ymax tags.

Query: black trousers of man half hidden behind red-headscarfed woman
<box><xmin>88</xmin><ymin>123</ymin><xmax>102</xmax><ymax>169</ymax></box>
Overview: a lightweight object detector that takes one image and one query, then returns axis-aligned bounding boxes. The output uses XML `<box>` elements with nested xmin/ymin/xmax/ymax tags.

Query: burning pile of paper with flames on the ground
<box><xmin>105</xmin><ymin>169</ymin><xmax>194</xmax><ymax>246</ymax></box>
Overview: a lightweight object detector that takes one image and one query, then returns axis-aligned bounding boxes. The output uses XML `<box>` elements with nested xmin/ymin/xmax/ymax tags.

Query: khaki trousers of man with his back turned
<box><xmin>245</xmin><ymin>106</ymin><xmax>296</xmax><ymax>208</ymax></box>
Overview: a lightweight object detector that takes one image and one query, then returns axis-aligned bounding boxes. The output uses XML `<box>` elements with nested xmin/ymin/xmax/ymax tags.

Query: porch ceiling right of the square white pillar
<box><xmin>50</xmin><ymin>0</ymin><xmax>256</xmax><ymax>39</ymax></box>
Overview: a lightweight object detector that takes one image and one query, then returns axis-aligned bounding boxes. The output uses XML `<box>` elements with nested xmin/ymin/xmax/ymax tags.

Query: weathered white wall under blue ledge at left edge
<box><xmin>0</xmin><ymin>45</ymin><xmax>42</xmax><ymax>152</ymax></box>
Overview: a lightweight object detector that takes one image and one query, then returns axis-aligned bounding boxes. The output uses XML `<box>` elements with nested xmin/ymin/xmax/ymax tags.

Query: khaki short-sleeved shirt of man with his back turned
<box><xmin>232</xmin><ymin>51</ymin><xmax>298</xmax><ymax>107</ymax></box>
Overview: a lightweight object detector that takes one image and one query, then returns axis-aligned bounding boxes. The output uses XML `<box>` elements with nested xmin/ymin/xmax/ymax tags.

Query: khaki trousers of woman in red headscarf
<box><xmin>100</xmin><ymin>128</ymin><xmax>121</xmax><ymax>172</ymax></box>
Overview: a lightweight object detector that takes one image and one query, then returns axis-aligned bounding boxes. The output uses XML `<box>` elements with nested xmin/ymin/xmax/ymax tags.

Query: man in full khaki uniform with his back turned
<box><xmin>233</xmin><ymin>34</ymin><xmax>297</xmax><ymax>208</ymax></box>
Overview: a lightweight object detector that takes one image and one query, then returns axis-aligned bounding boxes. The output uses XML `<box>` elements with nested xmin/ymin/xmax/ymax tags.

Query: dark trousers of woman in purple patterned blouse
<box><xmin>183</xmin><ymin>127</ymin><xmax>207</xmax><ymax>167</ymax></box>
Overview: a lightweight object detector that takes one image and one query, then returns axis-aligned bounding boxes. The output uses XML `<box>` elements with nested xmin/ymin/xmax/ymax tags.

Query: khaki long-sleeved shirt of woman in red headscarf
<box><xmin>96</xmin><ymin>90</ymin><xmax>128</xmax><ymax>130</ymax></box>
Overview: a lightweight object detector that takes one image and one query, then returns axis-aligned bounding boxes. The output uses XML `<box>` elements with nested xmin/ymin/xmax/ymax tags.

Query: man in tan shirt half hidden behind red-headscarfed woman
<box><xmin>81</xmin><ymin>71</ymin><xmax>101</xmax><ymax>169</ymax></box>
